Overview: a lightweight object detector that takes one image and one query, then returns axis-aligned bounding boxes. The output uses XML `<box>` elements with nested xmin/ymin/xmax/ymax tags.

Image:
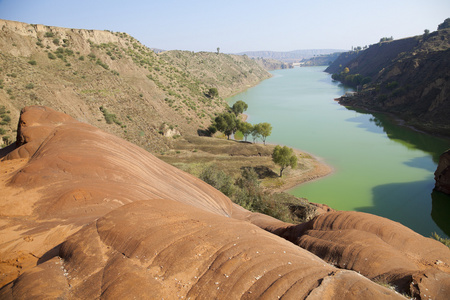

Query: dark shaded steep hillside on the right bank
<box><xmin>326</xmin><ymin>29</ymin><xmax>450</xmax><ymax>135</ymax></box>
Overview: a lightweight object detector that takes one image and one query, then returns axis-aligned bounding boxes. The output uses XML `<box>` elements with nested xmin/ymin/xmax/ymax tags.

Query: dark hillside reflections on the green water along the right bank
<box><xmin>347</xmin><ymin>107</ymin><xmax>450</xmax><ymax>237</ymax></box>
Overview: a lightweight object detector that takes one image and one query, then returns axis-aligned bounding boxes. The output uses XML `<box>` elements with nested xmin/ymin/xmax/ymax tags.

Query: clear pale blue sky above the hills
<box><xmin>0</xmin><ymin>0</ymin><xmax>450</xmax><ymax>53</ymax></box>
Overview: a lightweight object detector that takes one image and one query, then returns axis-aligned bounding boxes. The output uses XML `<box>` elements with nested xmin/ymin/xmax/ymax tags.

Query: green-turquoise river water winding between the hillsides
<box><xmin>228</xmin><ymin>67</ymin><xmax>450</xmax><ymax>236</ymax></box>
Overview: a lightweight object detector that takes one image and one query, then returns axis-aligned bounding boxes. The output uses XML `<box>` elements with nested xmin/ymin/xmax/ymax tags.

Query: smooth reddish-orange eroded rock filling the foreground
<box><xmin>0</xmin><ymin>106</ymin><xmax>450</xmax><ymax>299</ymax></box>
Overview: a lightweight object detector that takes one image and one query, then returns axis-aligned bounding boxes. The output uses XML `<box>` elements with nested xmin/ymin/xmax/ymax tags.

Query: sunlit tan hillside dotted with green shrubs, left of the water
<box><xmin>0</xmin><ymin>20</ymin><xmax>270</xmax><ymax>151</ymax></box>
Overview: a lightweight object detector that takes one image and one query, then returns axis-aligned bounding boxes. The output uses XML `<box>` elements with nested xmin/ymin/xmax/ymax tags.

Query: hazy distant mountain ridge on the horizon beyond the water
<box><xmin>236</xmin><ymin>49</ymin><xmax>347</xmax><ymax>63</ymax></box>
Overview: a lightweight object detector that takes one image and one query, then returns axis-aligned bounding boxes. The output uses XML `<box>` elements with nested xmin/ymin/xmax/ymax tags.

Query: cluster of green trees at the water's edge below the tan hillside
<box><xmin>208</xmin><ymin>100</ymin><xmax>272</xmax><ymax>145</ymax></box>
